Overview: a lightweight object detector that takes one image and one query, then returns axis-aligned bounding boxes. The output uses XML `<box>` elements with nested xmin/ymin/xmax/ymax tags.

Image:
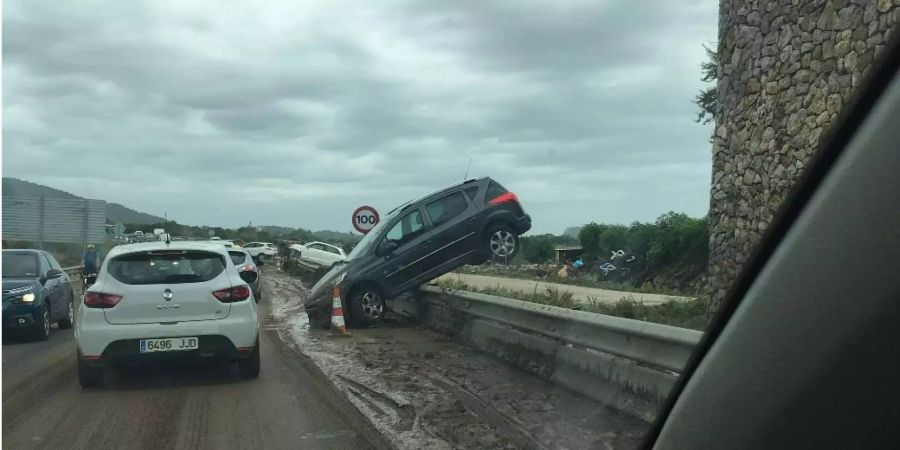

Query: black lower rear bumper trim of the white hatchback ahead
<box><xmin>79</xmin><ymin>335</ymin><xmax>258</xmax><ymax>367</ymax></box>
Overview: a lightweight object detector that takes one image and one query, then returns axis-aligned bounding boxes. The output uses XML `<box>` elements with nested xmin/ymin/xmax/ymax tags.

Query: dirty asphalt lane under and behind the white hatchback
<box><xmin>3</xmin><ymin>284</ymin><xmax>380</xmax><ymax>449</ymax></box>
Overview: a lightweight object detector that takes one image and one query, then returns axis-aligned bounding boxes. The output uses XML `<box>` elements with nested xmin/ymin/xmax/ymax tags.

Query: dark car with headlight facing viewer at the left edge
<box><xmin>3</xmin><ymin>250</ymin><xmax>75</xmax><ymax>340</ymax></box>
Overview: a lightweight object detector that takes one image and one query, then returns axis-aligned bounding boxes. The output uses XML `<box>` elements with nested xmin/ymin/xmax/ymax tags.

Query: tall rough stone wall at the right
<box><xmin>709</xmin><ymin>0</ymin><xmax>900</xmax><ymax>306</ymax></box>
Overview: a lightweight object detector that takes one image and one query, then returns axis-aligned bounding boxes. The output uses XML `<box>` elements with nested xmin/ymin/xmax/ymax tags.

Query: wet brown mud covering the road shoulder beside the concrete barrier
<box><xmin>263</xmin><ymin>270</ymin><xmax>648</xmax><ymax>449</ymax></box>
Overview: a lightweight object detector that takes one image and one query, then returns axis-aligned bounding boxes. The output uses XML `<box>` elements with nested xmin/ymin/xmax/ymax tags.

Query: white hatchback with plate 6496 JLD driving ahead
<box><xmin>75</xmin><ymin>242</ymin><xmax>259</xmax><ymax>387</ymax></box>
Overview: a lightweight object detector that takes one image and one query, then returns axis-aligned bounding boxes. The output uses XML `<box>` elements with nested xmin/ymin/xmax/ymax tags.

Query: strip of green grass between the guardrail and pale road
<box><xmin>437</xmin><ymin>278</ymin><xmax>708</xmax><ymax>331</ymax></box>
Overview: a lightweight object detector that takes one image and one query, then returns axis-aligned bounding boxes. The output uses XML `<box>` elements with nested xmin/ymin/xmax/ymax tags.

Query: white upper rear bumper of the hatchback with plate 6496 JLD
<box><xmin>75</xmin><ymin>304</ymin><xmax>259</xmax><ymax>357</ymax></box>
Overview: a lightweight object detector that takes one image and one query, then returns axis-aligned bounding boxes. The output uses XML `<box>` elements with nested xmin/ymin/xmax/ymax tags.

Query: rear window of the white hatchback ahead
<box><xmin>107</xmin><ymin>250</ymin><xmax>225</xmax><ymax>284</ymax></box>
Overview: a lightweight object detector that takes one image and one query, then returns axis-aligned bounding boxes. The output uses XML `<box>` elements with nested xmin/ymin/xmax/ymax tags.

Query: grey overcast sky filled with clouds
<box><xmin>2</xmin><ymin>0</ymin><xmax>718</xmax><ymax>233</ymax></box>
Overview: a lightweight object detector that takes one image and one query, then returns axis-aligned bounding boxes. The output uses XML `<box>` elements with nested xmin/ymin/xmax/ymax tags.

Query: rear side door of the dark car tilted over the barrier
<box><xmin>420</xmin><ymin>191</ymin><xmax>478</xmax><ymax>282</ymax></box>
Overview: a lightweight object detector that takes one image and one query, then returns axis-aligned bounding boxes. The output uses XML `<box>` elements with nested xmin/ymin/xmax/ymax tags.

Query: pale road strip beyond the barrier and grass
<box><xmin>438</xmin><ymin>273</ymin><xmax>690</xmax><ymax>304</ymax></box>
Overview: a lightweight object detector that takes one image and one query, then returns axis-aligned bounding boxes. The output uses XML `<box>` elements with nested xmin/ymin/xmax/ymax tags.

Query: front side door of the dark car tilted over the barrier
<box><xmin>378</xmin><ymin>208</ymin><xmax>432</xmax><ymax>297</ymax></box>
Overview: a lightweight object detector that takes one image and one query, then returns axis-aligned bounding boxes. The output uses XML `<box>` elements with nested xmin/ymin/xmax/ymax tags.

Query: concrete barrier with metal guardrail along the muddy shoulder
<box><xmin>390</xmin><ymin>286</ymin><xmax>702</xmax><ymax>421</ymax></box>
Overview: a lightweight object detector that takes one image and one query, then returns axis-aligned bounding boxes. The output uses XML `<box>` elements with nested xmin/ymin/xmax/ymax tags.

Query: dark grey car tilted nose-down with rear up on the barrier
<box><xmin>306</xmin><ymin>177</ymin><xmax>531</xmax><ymax>326</ymax></box>
